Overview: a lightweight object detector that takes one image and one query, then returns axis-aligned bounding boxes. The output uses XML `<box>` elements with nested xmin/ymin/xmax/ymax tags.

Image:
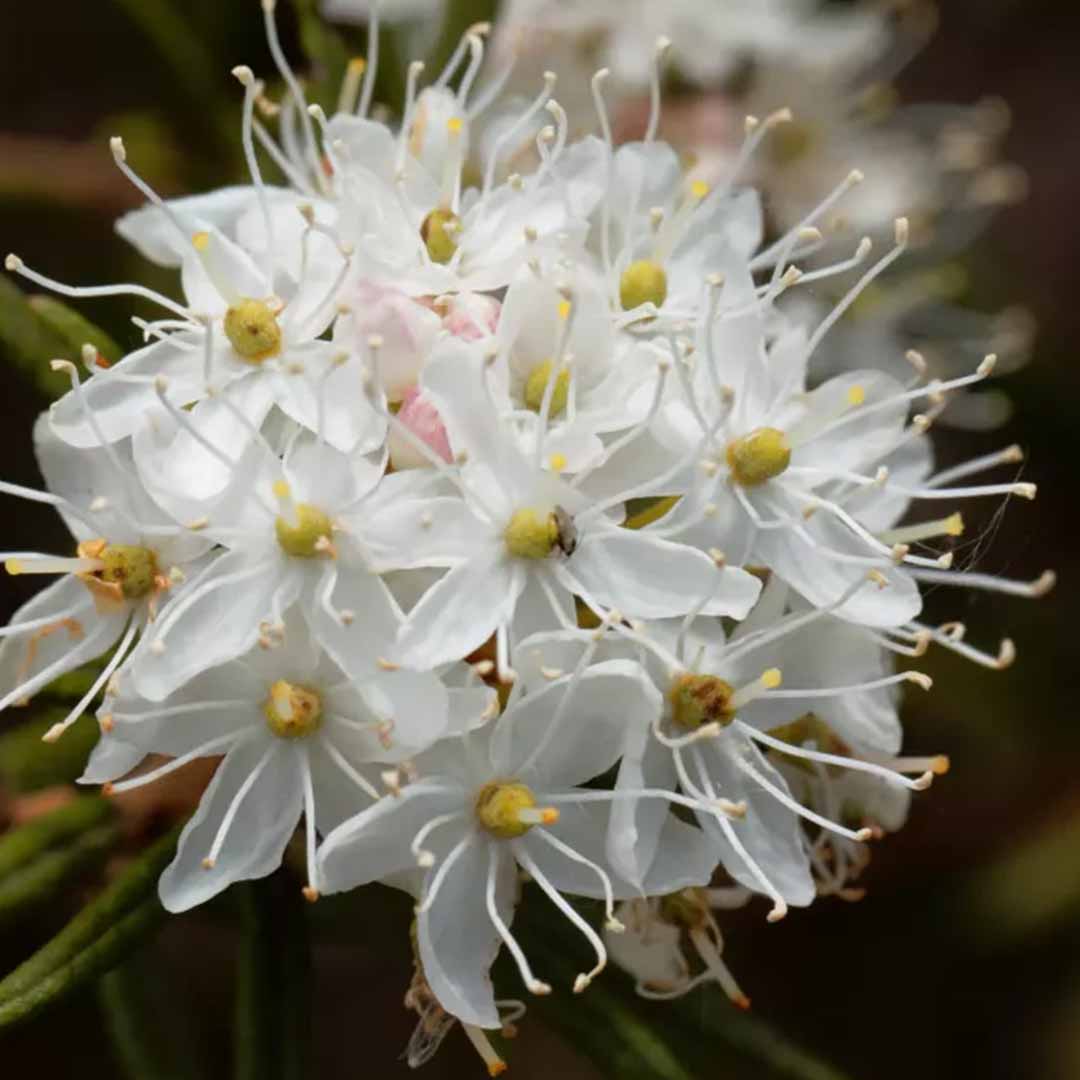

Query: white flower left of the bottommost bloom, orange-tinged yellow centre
<box><xmin>82</xmin><ymin>612</ymin><xmax>492</xmax><ymax>912</ymax></box>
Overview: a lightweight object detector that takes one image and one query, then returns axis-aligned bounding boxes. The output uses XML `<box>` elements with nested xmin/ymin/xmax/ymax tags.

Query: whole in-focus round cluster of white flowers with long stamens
<box><xmin>0</xmin><ymin>0</ymin><xmax>1051</xmax><ymax>1075</ymax></box>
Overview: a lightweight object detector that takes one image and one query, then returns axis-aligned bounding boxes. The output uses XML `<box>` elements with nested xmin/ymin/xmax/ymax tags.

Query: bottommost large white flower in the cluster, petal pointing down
<box><xmin>319</xmin><ymin>661</ymin><xmax>712</xmax><ymax>1028</ymax></box>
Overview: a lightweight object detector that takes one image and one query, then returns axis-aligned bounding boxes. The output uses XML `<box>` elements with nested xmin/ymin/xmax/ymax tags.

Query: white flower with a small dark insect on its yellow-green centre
<box><xmin>390</xmin><ymin>342</ymin><xmax>759</xmax><ymax>677</ymax></box>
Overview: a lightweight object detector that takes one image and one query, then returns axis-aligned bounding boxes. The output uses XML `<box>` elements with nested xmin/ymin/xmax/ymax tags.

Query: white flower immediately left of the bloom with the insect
<box><xmin>133</xmin><ymin>432</ymin><xmax>412</xmax><ymax>701</ymax></box>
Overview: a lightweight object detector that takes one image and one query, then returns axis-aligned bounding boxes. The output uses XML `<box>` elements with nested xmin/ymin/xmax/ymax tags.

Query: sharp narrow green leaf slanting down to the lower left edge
<box><xmin>0</xmin><ymin>825</ymin><xmax>180</xmax><ymax>1030</ymax></box>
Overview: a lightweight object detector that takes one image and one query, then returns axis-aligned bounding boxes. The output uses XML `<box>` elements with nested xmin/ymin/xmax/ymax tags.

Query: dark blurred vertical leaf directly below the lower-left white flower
<box><xmin>235</xmin><ymin>869</ymin><xmax>311</xmax><ymax>1080</ymax></box>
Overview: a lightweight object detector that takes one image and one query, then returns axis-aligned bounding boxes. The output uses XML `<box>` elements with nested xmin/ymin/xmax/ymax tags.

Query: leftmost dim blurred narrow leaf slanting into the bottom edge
<box><xmin>97</xmin><ymin>957</ymin><xmax>206</xmax><ymax>1080</ymax></box>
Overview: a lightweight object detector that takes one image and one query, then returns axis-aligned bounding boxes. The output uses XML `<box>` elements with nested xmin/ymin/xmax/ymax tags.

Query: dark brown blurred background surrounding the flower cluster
<box><xmin>0</xmin><ymin>0</ymin><xmax>1080</xmax><ymax>1080</ymax></box>
